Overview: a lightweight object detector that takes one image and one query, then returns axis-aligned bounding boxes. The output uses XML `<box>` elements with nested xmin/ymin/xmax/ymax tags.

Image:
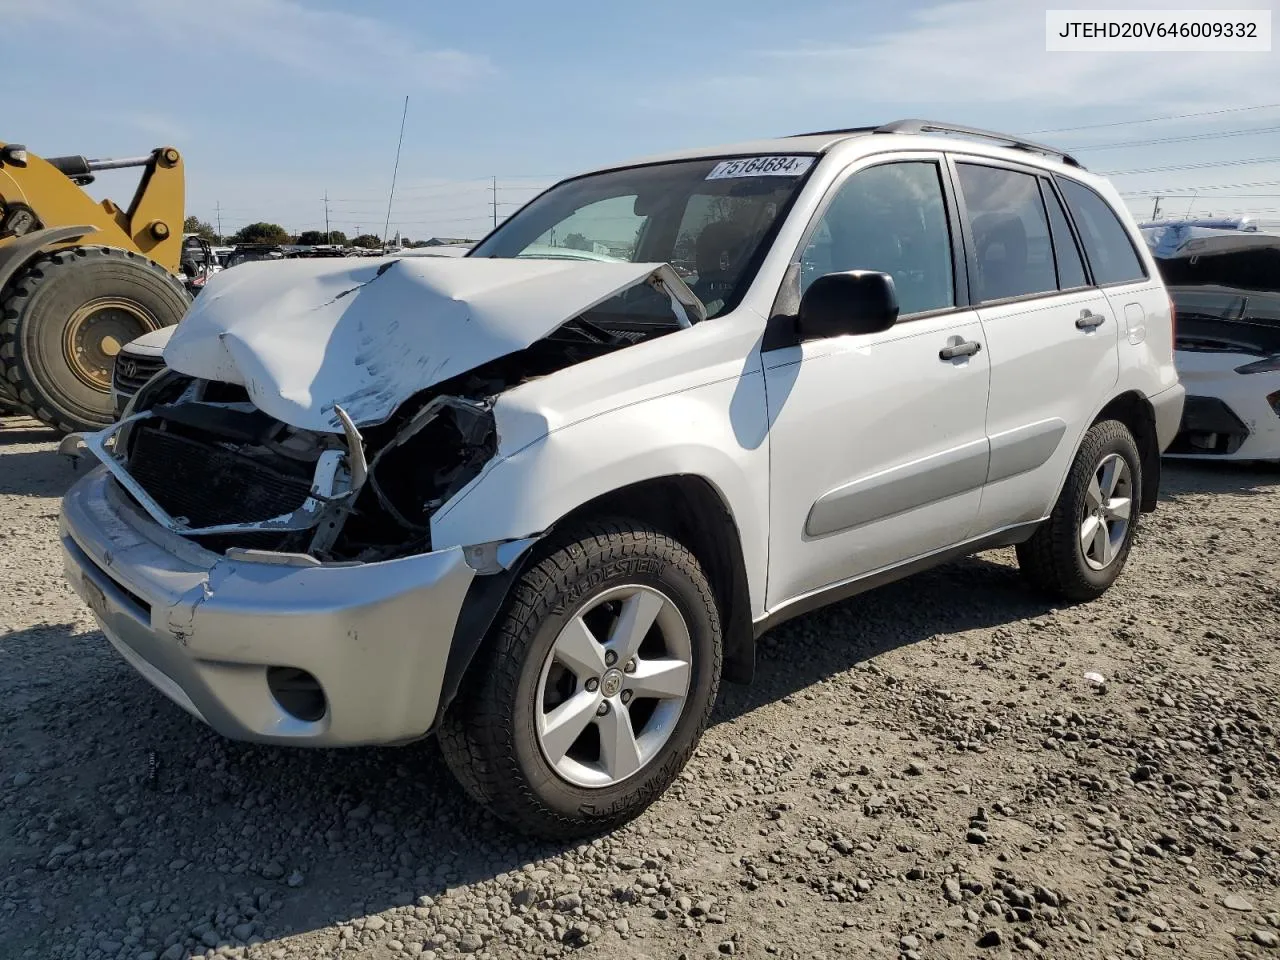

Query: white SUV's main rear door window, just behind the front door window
<box><xmin>956</xmin><ymin>163</ymin><xmax>1057</xmax><ymax>302</ymax></box>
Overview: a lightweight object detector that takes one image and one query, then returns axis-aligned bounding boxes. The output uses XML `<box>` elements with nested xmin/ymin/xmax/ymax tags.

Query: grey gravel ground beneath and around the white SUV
<box><xmin>0</xmin><ymin>421</ymin><xmax>1280</xmax><ymax>960</ymax></box>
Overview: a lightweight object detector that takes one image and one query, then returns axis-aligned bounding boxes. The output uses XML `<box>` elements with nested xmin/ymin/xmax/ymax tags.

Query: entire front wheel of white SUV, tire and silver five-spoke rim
<box><xmin>439</xmin><ymin>521</ymin><xmax>722</xmax><ymax>838</ymax></box>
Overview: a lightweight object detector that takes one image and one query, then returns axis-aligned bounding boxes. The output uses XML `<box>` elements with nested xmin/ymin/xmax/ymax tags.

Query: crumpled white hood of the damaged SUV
<box><xmin>164</xmin><ymin>257</ymin><xmax>700</xmax><ymax>433</ymax></box>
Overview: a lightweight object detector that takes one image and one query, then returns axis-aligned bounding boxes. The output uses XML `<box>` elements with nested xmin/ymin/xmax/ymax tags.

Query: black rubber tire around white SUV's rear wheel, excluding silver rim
<box><xmin>1018</xmin><ymin>420</ymin><xmax>1142</xmax><ymax>603</ymax></box>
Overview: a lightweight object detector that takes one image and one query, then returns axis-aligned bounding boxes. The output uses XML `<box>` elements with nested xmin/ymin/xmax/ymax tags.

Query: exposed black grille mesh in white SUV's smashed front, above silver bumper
<box><xmin>128</xmin><ymin>424</ymin><xmax>311</xmax><ymax>527</ymax></box>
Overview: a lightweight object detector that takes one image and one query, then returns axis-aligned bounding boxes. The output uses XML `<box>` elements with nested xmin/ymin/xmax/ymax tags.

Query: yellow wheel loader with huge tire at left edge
<box><xmin>0</xmin><ymin>141</ymin><xmax>191</xmax><ymax>431</ymax></box>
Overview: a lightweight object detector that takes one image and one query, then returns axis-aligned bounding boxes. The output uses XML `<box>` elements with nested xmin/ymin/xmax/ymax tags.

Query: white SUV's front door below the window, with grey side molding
<box><xmin>765</xmin><ymin>311</ymin><xmax>989</xmax><ymax>608</ymax></box>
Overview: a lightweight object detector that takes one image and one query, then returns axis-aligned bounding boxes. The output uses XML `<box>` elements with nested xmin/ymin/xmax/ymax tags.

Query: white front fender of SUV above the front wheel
<box><xmin>431</xmin><ymin>310</ymin><xmax>769</xmax><ymax>616</ymax></box>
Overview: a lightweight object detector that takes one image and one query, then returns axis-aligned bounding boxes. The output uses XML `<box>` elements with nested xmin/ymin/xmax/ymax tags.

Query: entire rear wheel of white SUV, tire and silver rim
<box><xmin>1018</xmin><ymin>420</ymin><xmax>1142</xmax><ymax>602</ymax></box>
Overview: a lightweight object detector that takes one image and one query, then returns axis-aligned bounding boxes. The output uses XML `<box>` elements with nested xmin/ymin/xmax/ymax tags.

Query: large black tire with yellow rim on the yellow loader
<box><xmin>0</xmin><ymin>247</ymin><xmax>191</xmax><ymax>433</ymax></box>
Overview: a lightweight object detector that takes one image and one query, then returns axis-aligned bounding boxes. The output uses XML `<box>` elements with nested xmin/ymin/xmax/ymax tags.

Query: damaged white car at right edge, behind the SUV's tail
<box><xmin>1144</xmin><ymin>227</ymin><xmax>1280</xmax><ymax>461</ymax></box>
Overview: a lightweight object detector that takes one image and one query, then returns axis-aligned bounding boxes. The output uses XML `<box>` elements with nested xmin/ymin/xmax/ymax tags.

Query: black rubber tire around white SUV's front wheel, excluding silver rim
<box><xmin>439</xmin><ymin>520</ymin><xmax>722</xmax><ymax>838</ymax></box>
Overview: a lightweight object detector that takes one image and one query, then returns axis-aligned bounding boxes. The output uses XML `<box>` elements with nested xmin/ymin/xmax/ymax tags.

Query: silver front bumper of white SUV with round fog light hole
<box><xmin>60</xmin><ymin>467</ymin><xmax>475</xmax><ymax>746</ymax></box>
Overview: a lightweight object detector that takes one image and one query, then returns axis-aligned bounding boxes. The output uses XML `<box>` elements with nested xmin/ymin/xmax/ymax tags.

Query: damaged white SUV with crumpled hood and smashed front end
<box><xmin>61</xmin><ymin>122</ymin><xmax>1183</xmax><ymax>836</ymax></box>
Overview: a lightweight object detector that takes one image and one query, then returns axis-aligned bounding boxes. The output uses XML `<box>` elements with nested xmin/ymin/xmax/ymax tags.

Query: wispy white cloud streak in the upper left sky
<box><xmin>0</xmin><ymin>0</ymin><xmax>495</xmax><ymax>90</ymax></box>
